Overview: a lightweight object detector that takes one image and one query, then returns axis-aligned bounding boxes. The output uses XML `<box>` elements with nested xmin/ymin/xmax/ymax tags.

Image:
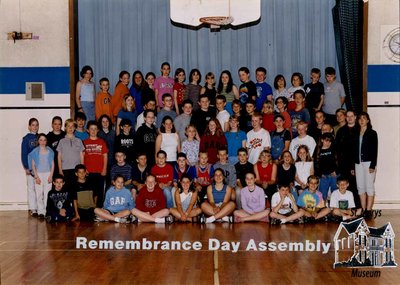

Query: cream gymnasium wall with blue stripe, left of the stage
<box><xmin>0</xmin><ymin>0</ymin><xmax>70</xmax><ymax>210</ymax></box>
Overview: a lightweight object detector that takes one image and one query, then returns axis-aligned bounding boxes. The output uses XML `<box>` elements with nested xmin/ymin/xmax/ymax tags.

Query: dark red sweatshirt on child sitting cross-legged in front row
<box><xmin>136</xmin><ymin>185</ymin><xmax>167</xmax><ymax>215</ymax></box>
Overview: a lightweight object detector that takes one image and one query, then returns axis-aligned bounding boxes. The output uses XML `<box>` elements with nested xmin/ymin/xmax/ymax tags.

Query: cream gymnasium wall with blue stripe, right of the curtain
<box><xmin>368</xmin><ymin>0</ymin><xmax>400</xmax><ymax>209</ymax></box>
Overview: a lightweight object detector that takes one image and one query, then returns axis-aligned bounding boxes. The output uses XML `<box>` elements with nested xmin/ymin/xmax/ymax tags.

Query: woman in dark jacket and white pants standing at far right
<box><xmin>352</xmin><ymin>112</ymin><xmax>378</xmax><ymax>217</ymax></box>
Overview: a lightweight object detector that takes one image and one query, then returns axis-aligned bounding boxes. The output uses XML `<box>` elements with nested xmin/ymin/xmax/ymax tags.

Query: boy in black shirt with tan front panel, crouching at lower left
<box><xmin>71</xmin><ymin>164</ymin><xmax>97</xmax><ymax>221</ymax></box>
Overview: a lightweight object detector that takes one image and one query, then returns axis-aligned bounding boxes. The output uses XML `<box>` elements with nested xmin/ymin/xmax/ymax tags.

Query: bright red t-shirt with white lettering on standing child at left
<box><xmin>83</xmin><ymin>138</ymin><xmax>108</xmax><ymax>173</ymax></box>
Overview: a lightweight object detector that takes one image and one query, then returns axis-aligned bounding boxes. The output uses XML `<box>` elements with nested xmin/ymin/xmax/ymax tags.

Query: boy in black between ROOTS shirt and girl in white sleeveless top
<box><xmin>135</xmin><ymin>109</ymin><xmax>157</xmax><ymax>166</ymax></box>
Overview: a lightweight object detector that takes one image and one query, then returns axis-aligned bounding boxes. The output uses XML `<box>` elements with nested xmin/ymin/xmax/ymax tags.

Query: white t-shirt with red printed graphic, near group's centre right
<box><xmin>246</xmin><ymin>128</ymin><xmax>271</xmax><ymax>164</ymax></box>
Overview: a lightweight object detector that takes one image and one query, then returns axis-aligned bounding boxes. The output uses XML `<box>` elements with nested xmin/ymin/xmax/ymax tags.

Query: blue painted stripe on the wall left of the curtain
<box><xmin>0</xmin><ymin>66</ymin><xmax>70</xmax><ymax>94</ymax></box>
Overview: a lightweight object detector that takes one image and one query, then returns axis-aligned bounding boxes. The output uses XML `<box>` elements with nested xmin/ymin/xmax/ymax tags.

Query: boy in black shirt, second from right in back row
<box><xmin>304</xmin><ymin>68</ymin><xmax>324</xmax><ymax>118</ymax></box>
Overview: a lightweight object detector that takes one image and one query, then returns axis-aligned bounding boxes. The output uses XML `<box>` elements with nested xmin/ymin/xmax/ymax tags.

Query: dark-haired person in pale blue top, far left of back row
<box><xmin>75</xmin><ymin>65</ymin><xmax>96</xmax><ymax>121</ymax></box>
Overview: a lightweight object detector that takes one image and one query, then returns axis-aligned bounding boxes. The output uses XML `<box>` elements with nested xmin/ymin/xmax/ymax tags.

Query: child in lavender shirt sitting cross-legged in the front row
<box><xmin>233</xmin><ymin>172</ymin><xmax>269</xmax><ymax>223</ymax></box>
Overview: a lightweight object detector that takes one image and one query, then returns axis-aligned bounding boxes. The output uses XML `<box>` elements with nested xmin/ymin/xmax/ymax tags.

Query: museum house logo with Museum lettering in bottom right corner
<box><xmin>333</xmin><ymin>215</ymin><xmax>397</xmax><ymax>270</ymax></box>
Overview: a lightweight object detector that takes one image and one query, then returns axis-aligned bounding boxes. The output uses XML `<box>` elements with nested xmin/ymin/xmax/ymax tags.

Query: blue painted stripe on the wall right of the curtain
<box><xmin>368</xmin><ymin>64</ymin><xmax>400</xmax><ymax>92</ymax></box>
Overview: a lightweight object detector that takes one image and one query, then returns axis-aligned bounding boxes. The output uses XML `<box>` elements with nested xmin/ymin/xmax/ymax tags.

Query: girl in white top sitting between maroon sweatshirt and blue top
<box><xmin>169</xmin><ymin>173</ymin><xmax>201</xmax><ymax>222</ymax></box>
